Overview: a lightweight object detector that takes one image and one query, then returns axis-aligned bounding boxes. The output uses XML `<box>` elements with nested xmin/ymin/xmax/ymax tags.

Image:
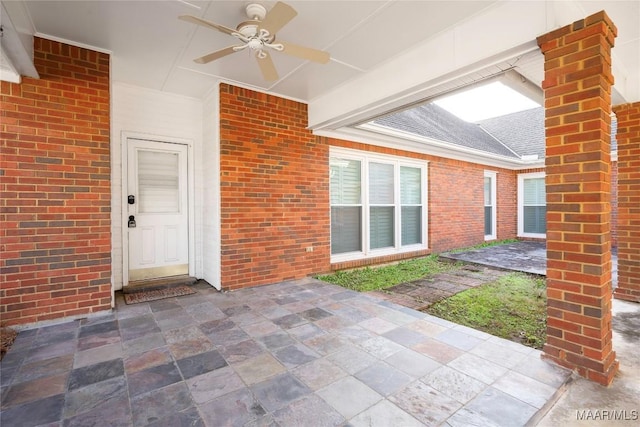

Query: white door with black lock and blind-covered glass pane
<box><xmin>125</xmin><ymin>138</ymin><xmax>189</xmax><ymax>281</ymax></box>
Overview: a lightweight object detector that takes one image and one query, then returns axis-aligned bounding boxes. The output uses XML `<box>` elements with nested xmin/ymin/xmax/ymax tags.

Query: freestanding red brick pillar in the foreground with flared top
<box><xmin>538</xmin><ymin>12</ymin><xmax>618</xmax><ymax>385</ymax></box>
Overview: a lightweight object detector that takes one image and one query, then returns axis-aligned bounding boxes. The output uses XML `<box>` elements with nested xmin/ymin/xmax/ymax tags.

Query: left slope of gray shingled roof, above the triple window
<box><xmin>374</xmin><ymin>104</ymin><xmax>518</xmax><ymax>158</ymax></box>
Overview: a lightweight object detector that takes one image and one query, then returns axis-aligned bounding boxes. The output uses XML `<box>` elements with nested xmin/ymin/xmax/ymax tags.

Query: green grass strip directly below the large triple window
<box><xmin>318</xmin><ymin>255</ymin><xmax>457</xmax><ymax>292</ymax></box>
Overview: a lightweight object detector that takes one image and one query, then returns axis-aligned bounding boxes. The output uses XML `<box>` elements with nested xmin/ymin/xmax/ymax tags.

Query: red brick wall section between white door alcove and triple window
<box><xmin>220</xmin><ymin>84</ymin><xmax>330</xmax><ymax>289</ymax></box>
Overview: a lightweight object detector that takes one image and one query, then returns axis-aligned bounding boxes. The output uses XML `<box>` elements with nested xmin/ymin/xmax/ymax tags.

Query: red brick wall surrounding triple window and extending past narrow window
<box><xmin>329</xmin><ymin>139</ymin><xmax>517</xmax><ymax>254</ymax></box>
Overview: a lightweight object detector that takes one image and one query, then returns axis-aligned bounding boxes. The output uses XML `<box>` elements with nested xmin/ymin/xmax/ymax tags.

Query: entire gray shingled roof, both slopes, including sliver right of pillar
<box><xmin>374</xmin><ymin>104</ymin><xmax>617</xmax><ymax>159</ymax></box>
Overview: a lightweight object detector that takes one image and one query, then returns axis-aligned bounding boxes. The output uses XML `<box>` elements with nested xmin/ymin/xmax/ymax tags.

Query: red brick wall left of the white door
<box><xmin>0</xmin><ymin>38</ymin><xmax>111</xmax><ymax>325</ymax></box>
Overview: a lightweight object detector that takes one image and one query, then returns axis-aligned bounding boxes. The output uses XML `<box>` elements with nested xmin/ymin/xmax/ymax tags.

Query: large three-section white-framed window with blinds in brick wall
<box><xmin>329</xmin><ymin>148</ymin><xmax>427</xmax><ymax>262</ymax></box>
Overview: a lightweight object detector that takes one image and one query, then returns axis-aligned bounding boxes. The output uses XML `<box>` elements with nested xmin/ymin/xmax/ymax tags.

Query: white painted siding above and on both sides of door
<box><xmin>111</xmin><ymin>83</ymin><xmax>204</xmax><ymax>290</ymax></box>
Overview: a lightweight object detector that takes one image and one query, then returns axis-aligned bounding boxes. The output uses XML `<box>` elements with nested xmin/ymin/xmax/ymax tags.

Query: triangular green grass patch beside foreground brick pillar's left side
<box><xmin>425</xmin><ymin>273</ymin><xmax>547</xmax><ymax>349</ymax></box>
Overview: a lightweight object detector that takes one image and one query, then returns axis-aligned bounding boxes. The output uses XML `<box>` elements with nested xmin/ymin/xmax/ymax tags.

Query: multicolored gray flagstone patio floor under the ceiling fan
<box><xmin>0</xmin><ymin>279</ymin><xmax>570</xmax><ymax>427</ymax></box>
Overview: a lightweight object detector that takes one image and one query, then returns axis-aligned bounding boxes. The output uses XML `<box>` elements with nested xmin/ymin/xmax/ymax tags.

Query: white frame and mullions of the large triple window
<box><xmin>329</xmin><ymin>147</ymin><xmax>429</xmax><ymax>263</ymax></box>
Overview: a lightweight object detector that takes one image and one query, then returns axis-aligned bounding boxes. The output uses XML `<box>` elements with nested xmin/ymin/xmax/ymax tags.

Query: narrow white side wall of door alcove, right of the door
<box><xmin>202</xmin><ymin>85</ymin><xmax>221</xmax><ymax>289</ymax></box>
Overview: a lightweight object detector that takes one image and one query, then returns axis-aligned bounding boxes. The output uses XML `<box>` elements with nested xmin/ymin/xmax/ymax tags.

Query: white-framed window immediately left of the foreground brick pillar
<box><xmin>518</xmin><ymin>172</ymin><xmax>547</xmax><ymax>238</ymax></box>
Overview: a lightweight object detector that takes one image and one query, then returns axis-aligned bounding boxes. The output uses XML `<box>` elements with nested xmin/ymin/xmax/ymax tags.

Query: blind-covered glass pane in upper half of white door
<box><xmin>138</xmin><ymin>150</ymin><xmax>180</xmax><ymax>213</ymax></box>
